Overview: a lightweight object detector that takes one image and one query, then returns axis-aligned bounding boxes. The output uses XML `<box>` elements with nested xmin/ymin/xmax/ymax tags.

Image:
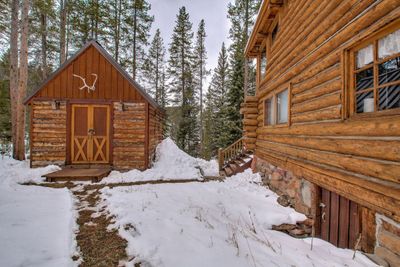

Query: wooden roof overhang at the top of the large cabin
<box><xmin>245</xmin><ymin>0</ymin><xmax>283</xmax><ymax>58</ymax></box>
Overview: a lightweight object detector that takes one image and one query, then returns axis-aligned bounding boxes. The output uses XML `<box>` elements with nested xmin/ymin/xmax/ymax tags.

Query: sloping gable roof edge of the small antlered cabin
<box><xmin>24</xmin><ymin>40</ymin><xmax>163</xmax><ymax>111</ymax></box>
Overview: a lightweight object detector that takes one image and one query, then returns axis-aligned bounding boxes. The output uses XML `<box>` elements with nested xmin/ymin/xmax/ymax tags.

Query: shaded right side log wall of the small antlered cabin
<box><xmin>148</xmin><ymin>106</ymin><xmax>165</xmax><ymax>165</ymax></box>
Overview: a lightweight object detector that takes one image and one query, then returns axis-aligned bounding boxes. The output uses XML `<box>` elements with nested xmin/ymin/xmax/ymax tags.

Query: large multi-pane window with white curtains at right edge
<box><xmin>352</xmin><ymin>26</ymin><xmax>400</xmax><ymax>113</ymax></box>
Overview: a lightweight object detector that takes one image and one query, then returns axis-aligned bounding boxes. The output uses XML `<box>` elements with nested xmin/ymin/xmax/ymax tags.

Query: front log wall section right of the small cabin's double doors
<box><xmin>112</xmin><ymin>102</ymin><xmax>146</xmax><ymax>170</ymax></box>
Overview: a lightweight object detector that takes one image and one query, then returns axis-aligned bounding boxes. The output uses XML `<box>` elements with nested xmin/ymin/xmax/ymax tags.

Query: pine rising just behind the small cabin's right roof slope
<box><xmin>144</xmin><ymin>29</ymin><xmax>167</xmax><ymax>107</ymax></box>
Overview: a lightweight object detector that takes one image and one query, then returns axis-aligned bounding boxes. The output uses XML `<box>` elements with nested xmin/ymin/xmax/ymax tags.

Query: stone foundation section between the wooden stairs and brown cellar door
<box><xmin>252</xmin><ymin>156</ymin><xmax>317</xmax><ymax>218</ymax></box>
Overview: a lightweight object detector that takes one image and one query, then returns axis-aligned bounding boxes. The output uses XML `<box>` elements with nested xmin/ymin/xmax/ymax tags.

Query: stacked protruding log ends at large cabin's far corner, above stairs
<box><xmin>240</xmin><ymin>96</ymin><xmax>258</xmax><ymax>151</ymax></box>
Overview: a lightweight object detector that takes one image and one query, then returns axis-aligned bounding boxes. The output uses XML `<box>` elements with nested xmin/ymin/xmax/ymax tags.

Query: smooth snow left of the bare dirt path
<box><xmin>0</xmin><ymin>158</ymin><xmax>77</xmax><ymax>267</ymax></box>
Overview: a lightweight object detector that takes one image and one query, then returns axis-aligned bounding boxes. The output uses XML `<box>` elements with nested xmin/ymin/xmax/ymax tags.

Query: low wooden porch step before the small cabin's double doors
<box><xmin>43</xmin><ymin>167</ymin><xmax>111</xmax><ymax>182</ymax></box>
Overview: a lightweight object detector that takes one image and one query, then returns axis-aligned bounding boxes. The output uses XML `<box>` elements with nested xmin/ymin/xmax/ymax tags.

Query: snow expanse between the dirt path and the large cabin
<box><xmin>102</xmin><ymin>170</ymin><xmax>374</xmax><ymax>267</ymax></box>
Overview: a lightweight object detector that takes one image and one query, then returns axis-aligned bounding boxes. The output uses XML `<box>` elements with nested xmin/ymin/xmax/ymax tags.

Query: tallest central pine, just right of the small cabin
<box><xmin>168</xmin><ymin>7</ymin><xmax>199</xmax><ymax>155</ymax></box>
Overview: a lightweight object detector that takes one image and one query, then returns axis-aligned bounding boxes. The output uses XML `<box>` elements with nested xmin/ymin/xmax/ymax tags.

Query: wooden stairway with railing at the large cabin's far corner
<box><xmin>218</xmin><ymin>138</ymin><xmax>253</xmax><ymax>177</ymax></box>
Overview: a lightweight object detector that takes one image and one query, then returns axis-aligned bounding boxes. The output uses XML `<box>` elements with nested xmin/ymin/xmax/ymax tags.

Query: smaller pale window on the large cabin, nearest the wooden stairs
<box><xmin>264</xmin><ymin>89</ymin><xmax>289</xmax><ymax>126</ymax></box>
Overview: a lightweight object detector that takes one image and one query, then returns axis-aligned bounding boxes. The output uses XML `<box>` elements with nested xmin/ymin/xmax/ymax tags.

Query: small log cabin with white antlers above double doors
<box><xmin>25</xmin><ymin>41</ymin><xmax>164</xmax><ymax>170</ymax></box>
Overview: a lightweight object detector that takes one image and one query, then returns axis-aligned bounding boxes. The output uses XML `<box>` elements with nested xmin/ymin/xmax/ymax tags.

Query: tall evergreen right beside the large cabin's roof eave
<box><xmin>226</xmin><ymin>0</ymin><xmax>261</xmax><ymax>146</ymax></box>
